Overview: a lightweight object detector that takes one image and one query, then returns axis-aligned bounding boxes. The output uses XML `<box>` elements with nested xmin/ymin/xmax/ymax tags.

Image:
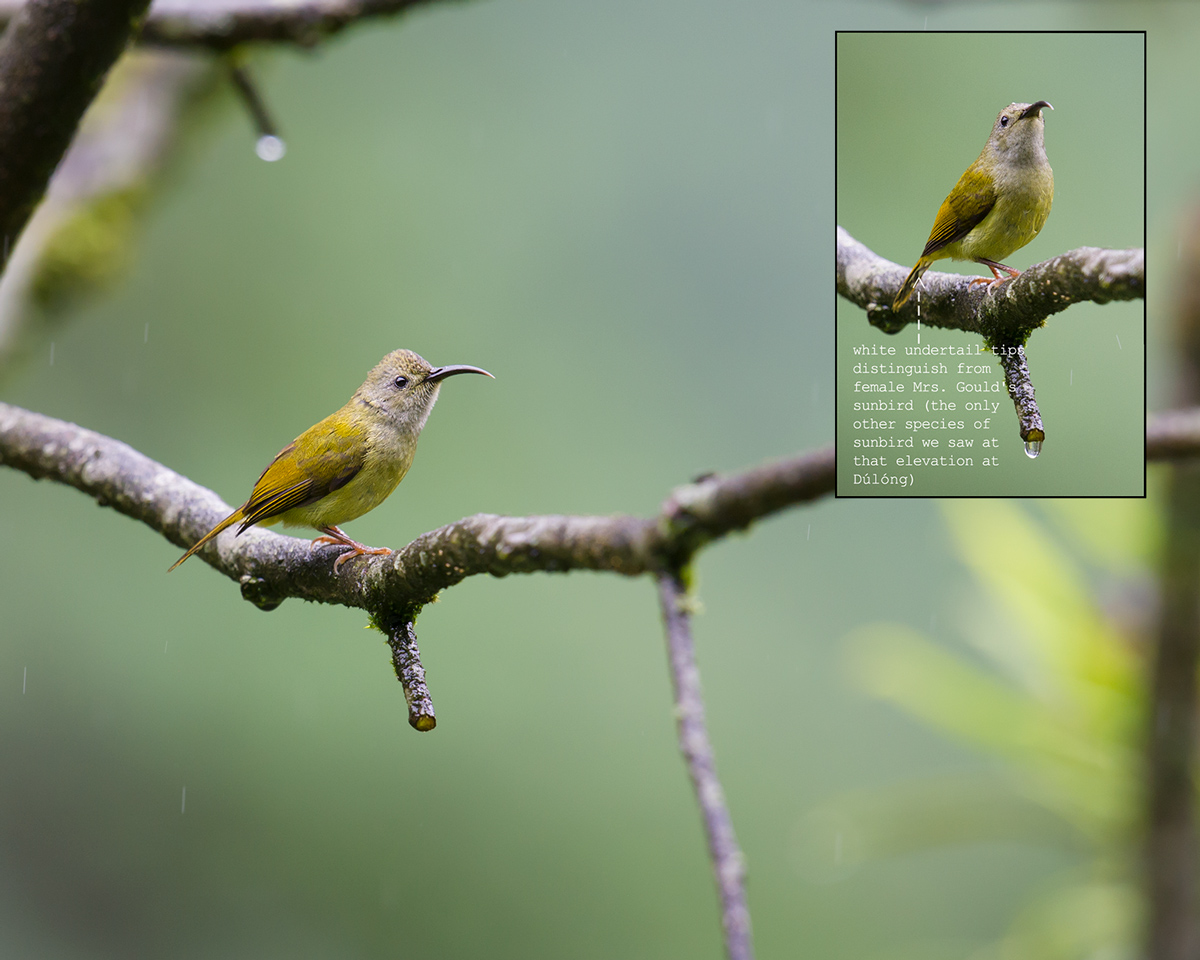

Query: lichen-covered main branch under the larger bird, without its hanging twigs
<box><xmin>0</xmin><ymin>403</ymin><xmax>834</xmax><ymax>619</ymax></box>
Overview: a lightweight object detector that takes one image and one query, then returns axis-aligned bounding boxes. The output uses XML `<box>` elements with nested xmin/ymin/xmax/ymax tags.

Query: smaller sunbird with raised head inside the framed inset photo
<box><xmin>892</xmin><ymin>100</ymin><xmax>1054</xmax><ymax>311</ymax></box>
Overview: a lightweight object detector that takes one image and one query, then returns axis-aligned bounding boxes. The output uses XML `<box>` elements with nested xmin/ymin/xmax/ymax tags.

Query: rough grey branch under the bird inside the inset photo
<box><xmin>838</xmin><ymin>227</ymin><xmax>1146</xmax><ymax>346</ymax></box>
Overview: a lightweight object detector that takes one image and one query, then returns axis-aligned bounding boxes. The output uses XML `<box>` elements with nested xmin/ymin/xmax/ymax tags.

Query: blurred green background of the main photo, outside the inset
<box><xmin>0</xmin><ymin>0</ymin><xmax>1200</xmax><ymax>960</ymax></box>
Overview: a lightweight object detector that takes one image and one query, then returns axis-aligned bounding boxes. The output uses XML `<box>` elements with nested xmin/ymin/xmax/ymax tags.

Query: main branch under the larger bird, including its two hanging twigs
<box><xmin>0</xmin><ymin>403</ymin><xmax>834</xmax><ymax>960</ymax></box>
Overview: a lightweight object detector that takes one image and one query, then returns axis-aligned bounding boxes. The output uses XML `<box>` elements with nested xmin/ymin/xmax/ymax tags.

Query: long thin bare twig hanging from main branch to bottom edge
<box><xmin>656</xmin><ymin>570</ymin><xmax>754</xmax><ymax>960</ymax></box>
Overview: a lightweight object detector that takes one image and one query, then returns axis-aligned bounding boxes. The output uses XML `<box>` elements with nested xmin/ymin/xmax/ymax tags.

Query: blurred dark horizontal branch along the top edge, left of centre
<box><xmin>0</xmin><ymin>0</ymin><xmax>460</xmax><ymax>50</ymax></box>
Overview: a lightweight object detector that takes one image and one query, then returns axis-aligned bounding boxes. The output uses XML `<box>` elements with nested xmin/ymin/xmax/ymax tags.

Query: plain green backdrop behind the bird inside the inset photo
<box><xmin>838</xmin><ymin>31</ymin><xmax>1146</xmax><ymax>497</ymax></box>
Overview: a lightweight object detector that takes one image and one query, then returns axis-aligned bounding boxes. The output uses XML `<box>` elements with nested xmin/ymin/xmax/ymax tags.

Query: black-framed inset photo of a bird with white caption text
<box><xmin>835</xmin><ymin>32</ymin><xmax>1146</xmax><ymax>497</ymax></box>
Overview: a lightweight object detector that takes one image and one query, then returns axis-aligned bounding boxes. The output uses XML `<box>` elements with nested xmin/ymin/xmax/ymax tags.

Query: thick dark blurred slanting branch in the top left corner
<box><xmin>0</xmin><ymin>0</ymin><xmax>149</xmax><ymax>269</ymax></box>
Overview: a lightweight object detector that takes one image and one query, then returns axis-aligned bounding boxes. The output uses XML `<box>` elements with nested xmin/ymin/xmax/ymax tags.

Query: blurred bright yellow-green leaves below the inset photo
<box><xmin>840</xmin><ymin>500</ymin><xmax>1154</xmax><ymax>960</ymax></box>
